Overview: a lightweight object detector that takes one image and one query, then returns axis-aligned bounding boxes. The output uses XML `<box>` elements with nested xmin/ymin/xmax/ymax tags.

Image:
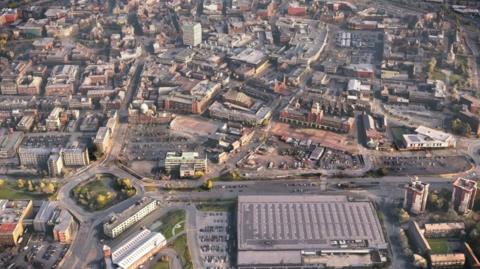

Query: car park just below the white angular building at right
<box><xmin>376</xmin><ymin>156</ymin><xmax>472</xmax><ymax>175</ymax></box>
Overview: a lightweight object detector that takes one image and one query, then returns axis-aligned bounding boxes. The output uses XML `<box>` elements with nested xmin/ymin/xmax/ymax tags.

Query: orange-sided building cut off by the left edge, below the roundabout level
<box><xmin>0</xmin><ymin>200</ymin><xmax>33</xmax><ymax>246</ymax></box>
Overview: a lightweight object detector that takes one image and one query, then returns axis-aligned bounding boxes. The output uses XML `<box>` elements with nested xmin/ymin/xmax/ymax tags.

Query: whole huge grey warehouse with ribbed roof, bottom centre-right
<box><xmin>237</xmin><ymin>195</ymin><xmax>387</xmax><ymax>269</ymax></box>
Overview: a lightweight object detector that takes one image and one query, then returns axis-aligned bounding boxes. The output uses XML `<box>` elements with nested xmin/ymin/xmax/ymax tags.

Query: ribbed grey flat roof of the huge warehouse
<box><xmin>237</xmin><ymin>195</ymin><xmax>387</xmax><ymax>252</ymax></box>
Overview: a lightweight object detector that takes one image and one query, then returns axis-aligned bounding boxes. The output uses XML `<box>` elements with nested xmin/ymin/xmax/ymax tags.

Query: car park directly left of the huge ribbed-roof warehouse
<box><xmin>198</xmin><ymin>211</ymin><xmax>234</xmax><ymax>269</ymax></box>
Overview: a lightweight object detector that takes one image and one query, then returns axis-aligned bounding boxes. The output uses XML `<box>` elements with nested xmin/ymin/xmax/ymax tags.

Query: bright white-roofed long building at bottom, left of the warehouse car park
<box><xmin>107</xmin><ymin>229</ymin><xmax>167</xmax><ymax>269</ymax></box>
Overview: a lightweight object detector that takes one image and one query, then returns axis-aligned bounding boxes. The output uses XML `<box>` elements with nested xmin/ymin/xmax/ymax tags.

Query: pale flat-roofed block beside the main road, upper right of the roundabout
<box><xmin>163</xmin><ymin>152</ymin><xmax>207</xmax><ymax>177</ymax></box>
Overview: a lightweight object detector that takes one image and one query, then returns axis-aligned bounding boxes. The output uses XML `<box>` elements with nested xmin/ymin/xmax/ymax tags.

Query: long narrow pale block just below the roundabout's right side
<box><xmin>103</xmin><ymin>197</ymin><xmax>158</xmax><ymax>238</ymax></box>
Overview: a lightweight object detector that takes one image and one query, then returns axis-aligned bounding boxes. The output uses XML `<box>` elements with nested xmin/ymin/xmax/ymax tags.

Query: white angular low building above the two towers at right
<box><xmin>403</xmin><ymin>126</ymin><xmax>457</xmax><ymax>149</ymax></box>
